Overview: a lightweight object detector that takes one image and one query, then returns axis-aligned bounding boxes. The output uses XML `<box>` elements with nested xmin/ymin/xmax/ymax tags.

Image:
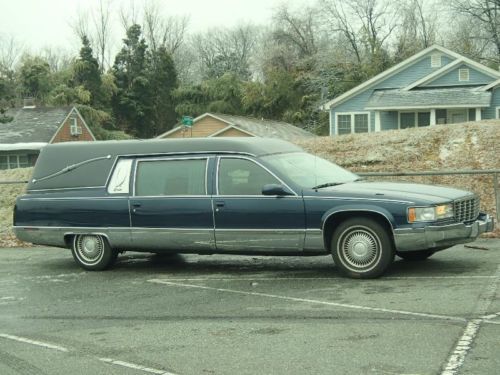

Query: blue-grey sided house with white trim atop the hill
<box><xmin>323</xmin><ymin>45</ymin><xmax>500</xmax><ymax>136</ymax></box>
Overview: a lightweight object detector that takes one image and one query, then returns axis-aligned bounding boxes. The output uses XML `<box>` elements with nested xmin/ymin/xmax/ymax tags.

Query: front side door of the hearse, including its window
<box><xmin>213</xmin><ymin>156</ymin><xmax>305</xmax><ymax>253</ymax></box>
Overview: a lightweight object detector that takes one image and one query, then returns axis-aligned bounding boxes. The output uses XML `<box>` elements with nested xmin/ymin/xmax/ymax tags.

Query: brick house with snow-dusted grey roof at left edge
<box><xmin>0</xmin><ymin>106</ymin><xmax>96</xmax><ymax>169</ymax></box>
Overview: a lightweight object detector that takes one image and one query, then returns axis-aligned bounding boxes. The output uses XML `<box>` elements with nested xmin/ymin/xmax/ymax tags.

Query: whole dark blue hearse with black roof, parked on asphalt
<box><xmin>14</xmin><ymin>138</ymin><xmax>494</xmax><ymax>278</ymax></box>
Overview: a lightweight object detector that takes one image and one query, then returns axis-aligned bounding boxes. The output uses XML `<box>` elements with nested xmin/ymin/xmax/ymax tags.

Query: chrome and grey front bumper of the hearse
<box><xmin>394</xmin><ymin>213</ymin><xmax>495</xmax><ymax>251</ymax></box>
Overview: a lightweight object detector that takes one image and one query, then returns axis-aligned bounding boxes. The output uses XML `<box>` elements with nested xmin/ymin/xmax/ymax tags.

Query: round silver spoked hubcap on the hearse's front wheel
<box><xmin>341</xmin><ymin>228</ymin><xmax>380</xmax><ymax>268</ymax></box>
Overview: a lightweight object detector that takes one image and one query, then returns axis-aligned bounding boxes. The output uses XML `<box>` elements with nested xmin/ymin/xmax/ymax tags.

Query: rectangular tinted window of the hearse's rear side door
<box><xmin>135</xmin><ymin>159</ymin><xmax>207</xmax><ymax>196</ymax></box>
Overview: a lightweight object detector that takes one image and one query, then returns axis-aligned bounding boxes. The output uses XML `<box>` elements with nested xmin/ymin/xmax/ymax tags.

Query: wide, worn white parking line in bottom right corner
<box><xmin>441</xmin><ymin>266</ymin><xmax>500</xmax><ymax>375</ymax></box>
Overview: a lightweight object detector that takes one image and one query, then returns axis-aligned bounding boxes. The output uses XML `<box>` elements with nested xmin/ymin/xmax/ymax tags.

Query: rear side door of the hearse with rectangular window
<box><xmin>129</xmin><ymin>157</ymin><xmax>215</xmax><ymax>251</ymax></box>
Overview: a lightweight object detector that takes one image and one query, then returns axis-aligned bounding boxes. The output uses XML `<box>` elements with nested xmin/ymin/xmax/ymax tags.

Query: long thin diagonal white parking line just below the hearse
<box><xmin>148</xmin><ymin>279</ymin><xmax>466</xmax><ymax>322</ymax></box>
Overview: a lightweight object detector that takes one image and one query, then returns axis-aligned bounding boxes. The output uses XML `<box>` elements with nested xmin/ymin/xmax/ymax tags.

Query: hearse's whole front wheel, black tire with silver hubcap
<box><xmin>330</xmin><ymin>217</ymin><xmax>394</xmax><ymax>279</ymax></box>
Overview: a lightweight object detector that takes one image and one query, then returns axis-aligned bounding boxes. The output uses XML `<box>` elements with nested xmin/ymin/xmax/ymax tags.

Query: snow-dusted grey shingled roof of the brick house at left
<box><xmin>0</xmin><ymin>107</ymin><xmax>71</xmax><ymax>144</ymax></box>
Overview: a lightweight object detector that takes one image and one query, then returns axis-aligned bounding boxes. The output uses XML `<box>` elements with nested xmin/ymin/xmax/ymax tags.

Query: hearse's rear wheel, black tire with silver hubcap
<box><xmin>71</xmin><ymin>234</ymin><xmax>118</xmax><ymax>271</ymax></box>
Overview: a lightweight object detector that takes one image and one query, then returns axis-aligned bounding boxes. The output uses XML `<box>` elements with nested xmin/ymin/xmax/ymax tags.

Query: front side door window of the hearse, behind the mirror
<box><xmin>219</xmin><ymin>158</ymin><xmax>280</xmax><ymax>195</ymax></box>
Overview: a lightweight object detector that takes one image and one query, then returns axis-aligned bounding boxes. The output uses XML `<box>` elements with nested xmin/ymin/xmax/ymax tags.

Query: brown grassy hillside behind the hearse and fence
<box><xmin>0</xmin><ymin>120</ymin><xmax>500</xmax><ymax>247</ymax></box>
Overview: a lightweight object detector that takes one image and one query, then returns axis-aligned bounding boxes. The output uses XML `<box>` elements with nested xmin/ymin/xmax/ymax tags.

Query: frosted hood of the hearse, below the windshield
<box><xmin>306</xmin><ymin>181</ymin><xmax>474</xmax><ymax>204</ymax></box>
